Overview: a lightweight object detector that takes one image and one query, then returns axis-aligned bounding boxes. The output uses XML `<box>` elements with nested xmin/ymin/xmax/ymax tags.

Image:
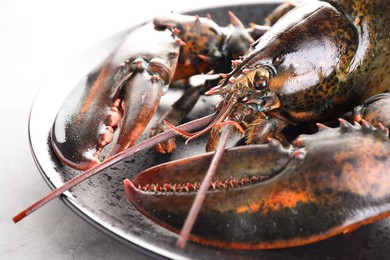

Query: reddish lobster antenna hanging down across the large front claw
<box><xmin>176</xmin><ymin>124</ymin><xmax>234</xmax><ymax>249</ymax></box>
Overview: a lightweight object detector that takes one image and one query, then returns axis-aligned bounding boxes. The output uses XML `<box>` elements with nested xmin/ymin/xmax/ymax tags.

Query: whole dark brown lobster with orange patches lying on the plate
<box><xmin>14</xmin><ymin>0</ymin><xmax>390</xmax><ymax>252</ymax></box>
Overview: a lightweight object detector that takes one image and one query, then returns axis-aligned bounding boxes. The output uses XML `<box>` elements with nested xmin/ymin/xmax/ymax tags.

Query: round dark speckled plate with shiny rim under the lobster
<box><xmin>29</xmin><ymin>4</ymin><xmax>390</xmax><ymax>259</ymax></box>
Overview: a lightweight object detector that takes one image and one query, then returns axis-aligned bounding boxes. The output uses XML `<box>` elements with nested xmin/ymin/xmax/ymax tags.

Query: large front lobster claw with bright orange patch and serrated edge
<box><xmin>124</xmin><ymin>124</ymin><xmax>390</xmax><ymax>249</ymax></box>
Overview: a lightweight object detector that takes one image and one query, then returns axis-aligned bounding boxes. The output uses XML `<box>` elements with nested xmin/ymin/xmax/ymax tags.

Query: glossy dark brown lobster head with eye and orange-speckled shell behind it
<box><xmin>203</xmin><ymin>1</ymin><xmax>364</xmax><ymax>143</ymax></box>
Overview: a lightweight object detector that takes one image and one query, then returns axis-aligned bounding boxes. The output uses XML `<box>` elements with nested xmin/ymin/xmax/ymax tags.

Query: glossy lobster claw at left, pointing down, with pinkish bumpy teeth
<box><xmin>51</xmin><ymin>23</ymin><xmax>181</xmax><ymax>170</ymax></box>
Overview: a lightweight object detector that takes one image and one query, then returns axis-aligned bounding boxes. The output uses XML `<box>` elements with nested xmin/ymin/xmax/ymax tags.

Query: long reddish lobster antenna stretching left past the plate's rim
<box><xmin>12</xmin><ymin>114</ymin><xmax>215</xmax><ymax>223</ymax></box>
